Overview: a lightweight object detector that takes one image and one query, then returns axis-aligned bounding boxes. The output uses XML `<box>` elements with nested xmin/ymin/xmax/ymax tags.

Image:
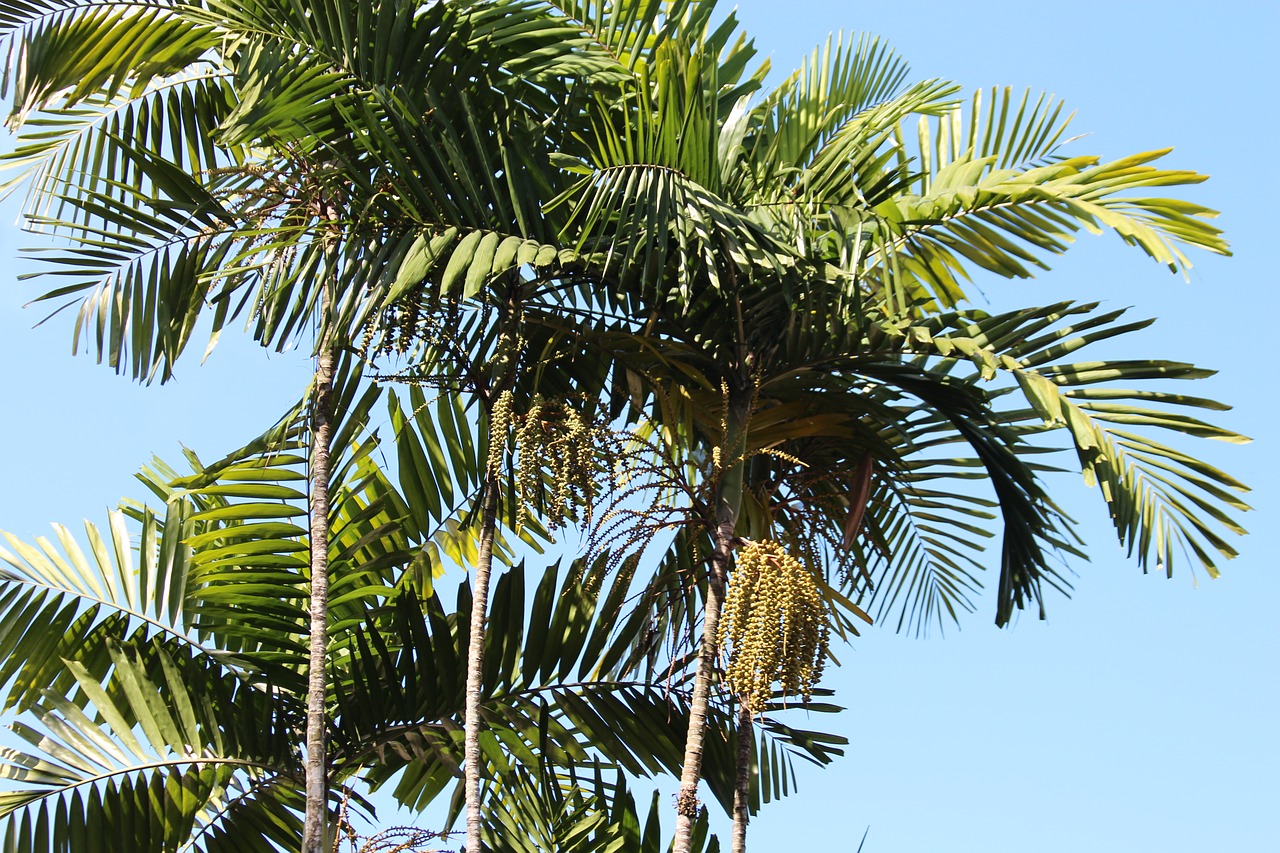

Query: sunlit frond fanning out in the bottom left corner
<box><xmin>0</xmin><ymin>639</ymin><xmax>300</xmax><ymax>853</ymax></box>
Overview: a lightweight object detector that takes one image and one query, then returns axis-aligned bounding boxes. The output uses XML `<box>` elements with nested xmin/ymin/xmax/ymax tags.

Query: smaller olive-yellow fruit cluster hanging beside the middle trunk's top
<box><xmin>489</xmin><ymin>391</ymin><xmax>608</xmax><ymax>524</ymax></box>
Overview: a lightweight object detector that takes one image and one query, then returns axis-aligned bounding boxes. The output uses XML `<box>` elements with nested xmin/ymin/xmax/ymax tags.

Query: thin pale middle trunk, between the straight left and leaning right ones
<box><xmin>462</xmin><ymin>468</ymin><xmax>498</xmax><ymax>853</ymax></box>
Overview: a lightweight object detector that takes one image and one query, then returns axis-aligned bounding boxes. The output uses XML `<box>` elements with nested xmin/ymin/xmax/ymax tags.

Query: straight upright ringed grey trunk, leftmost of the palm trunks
<box><xmin>302</xmin><ymin>338</ymin><xmax>334</xmax><ymax>853</ymax></box>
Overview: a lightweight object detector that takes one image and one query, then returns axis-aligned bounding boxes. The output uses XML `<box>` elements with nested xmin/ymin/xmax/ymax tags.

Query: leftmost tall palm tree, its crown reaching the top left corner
<box><xmin>0</xmin><ymin>0</ymin><xmax>637</xmax><ymax>850</ymax></box>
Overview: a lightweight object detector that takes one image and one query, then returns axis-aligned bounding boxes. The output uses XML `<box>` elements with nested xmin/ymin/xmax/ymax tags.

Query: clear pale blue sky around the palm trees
<box><xmin>0</xmin><ymin>0</ymin><xmax>1280</xmax><ymax>853</ymax></box>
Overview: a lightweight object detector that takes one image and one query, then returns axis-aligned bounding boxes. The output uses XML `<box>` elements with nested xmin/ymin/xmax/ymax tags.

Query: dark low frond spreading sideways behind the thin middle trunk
<box><xmin>335</xmin><ymin>557</ymin><xmax>841</xmax><ymax>809</ymax></box>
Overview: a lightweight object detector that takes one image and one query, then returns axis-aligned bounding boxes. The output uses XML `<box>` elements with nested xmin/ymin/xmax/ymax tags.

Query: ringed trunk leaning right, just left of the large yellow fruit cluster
<box><xmin>672</xmin><ymin>391</ymin><xmax>750</xmax><ymax>853</ymax></box>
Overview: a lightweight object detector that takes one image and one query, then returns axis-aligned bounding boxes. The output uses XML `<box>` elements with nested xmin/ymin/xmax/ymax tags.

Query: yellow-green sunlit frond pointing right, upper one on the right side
<box><xmin>873</xmin><ymin>88</ymin><xmax>1228</xmax><ymax>304</ymax></box>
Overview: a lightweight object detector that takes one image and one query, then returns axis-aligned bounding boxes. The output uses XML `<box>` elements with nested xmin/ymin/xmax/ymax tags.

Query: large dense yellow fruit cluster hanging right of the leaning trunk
<box><xmin>717</xmin><ymin>540</ymin><xmax>828</xmax><ymax>713</ymax></box>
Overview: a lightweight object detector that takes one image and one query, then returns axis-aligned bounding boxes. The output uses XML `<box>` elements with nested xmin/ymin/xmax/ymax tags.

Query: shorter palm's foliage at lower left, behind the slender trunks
<box><xmin>0</xmin><ymin>364</ymin><xmax>829</xmax><ymax>850</ymax></box>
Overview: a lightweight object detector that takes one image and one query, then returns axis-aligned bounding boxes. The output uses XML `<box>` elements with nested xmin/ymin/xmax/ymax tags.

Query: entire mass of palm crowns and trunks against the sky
<box><xmin>0</xmin><ymin>0</ymin><xmax>1247</xmax><ymax>850</ymax></box>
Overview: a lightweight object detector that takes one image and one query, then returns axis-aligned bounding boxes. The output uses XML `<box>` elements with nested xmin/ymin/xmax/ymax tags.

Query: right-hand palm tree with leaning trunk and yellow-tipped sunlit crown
<box><xmin>537</xmin><ymin>5</ymin><xmax>1244</xmax><ymax>850</ymax></box>
